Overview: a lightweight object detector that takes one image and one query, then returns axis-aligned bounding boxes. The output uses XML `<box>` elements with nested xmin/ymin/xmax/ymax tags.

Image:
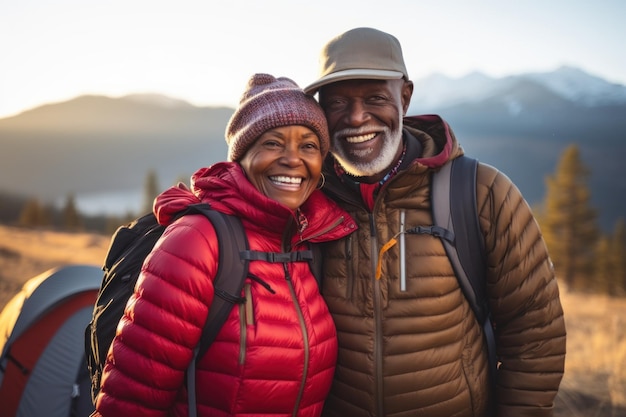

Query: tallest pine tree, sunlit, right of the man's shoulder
<box><xmin>542</xmin><ymin>145</ymin><xmax>599</xmax><ymax>289</ymax></box>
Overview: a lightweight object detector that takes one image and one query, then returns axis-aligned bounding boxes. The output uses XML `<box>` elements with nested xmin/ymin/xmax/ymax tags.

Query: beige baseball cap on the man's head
<box><xmin>304</xmin><ymin>27</ymin><xmax>409</xmax><ymax>94</ymax></box>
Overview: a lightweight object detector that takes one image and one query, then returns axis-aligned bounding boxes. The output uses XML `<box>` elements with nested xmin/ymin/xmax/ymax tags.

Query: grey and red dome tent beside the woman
<box><xmin>0</xmin><ymin>265</ymin><xmax>102</xmax><ymax>417</ymax></box>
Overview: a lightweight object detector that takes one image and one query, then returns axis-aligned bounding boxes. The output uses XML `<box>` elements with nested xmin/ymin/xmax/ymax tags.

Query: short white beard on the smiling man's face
<box><xmin>330</xmin><ymin>119</ymin><xmax>402</xmax><ymax>177</ymax></box>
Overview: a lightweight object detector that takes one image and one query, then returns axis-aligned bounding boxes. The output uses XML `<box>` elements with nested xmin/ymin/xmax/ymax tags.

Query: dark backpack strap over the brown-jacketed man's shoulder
<box><xmin>432</xmin><ymin>156</ymin><xmax>497</xmax><ymax>406</ymax></box>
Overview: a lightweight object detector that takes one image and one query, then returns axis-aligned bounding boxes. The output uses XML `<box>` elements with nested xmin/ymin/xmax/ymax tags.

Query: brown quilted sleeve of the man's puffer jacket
<box><xmin>477</xmin><ymin>165</ymin><xmax>566</xmax><ymax>417</ymax></box>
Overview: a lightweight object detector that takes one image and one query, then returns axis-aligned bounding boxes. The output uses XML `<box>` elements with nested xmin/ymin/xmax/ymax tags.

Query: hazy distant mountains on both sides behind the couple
<box><xmin>0</xmin><ymin>67</ymin><xmax>626</xmax><ymax>230</ymax></box>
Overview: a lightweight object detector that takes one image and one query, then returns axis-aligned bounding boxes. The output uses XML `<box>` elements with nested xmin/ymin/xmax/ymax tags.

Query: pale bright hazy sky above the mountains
<box><xmin>0</xmin><ymin>0</ymin><xmax>626</xmax><ymax>118</ymax></box>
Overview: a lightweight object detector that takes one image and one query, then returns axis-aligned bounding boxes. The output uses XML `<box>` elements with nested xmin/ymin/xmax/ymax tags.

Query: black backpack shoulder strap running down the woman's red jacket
<box><xmin>182</xmin><ymin>204</ymin><xmax>249</xmax><ymax>417</ymax></box>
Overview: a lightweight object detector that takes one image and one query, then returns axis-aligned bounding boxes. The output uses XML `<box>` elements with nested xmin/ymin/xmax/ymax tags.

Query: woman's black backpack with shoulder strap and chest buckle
<box><xmin>85</xmin><ymin>203</ymin><xmax>322</xmax><ymax>416</ymax></box>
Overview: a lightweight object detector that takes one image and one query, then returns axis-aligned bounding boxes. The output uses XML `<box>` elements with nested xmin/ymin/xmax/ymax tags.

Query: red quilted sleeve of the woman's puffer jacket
<box><xmin>96</xmin><ymin>216</ymin><xmax>217</xmax><ymax>417</ymax></box>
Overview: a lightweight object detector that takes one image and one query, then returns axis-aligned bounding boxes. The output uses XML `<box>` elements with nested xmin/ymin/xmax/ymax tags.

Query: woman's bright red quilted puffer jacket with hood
<box><xmin>96</xmin><ymin>162</ymin><xmax>356</xmax><ymax>417</ymax></box>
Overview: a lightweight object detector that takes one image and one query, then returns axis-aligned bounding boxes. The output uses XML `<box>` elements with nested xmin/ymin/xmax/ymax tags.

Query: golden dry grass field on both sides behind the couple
<box><xmin>0</xmin><ymin>226</ymin><xmax>626</xmax><ymax>417</ymax></box>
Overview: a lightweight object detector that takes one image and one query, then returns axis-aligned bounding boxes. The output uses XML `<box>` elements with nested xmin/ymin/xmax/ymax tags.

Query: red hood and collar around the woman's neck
<box><xmin>154</xmin><ymin>162</ymin><xmax>357</xmax><ymax>242</ymax></box>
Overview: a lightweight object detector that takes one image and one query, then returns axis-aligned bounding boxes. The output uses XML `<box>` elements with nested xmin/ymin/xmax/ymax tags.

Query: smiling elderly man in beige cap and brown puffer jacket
<box><xmin>305</xmin><ymin>28</ymin><xmax>566</xmax><ymax>417</ymax></box>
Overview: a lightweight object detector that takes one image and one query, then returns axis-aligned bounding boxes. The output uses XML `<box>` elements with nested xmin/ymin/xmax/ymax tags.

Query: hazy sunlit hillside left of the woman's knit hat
<box><xmin>0</xmin><ymin>96</ymin><xmax>233</xmax><ymax>206</ymax></box>
